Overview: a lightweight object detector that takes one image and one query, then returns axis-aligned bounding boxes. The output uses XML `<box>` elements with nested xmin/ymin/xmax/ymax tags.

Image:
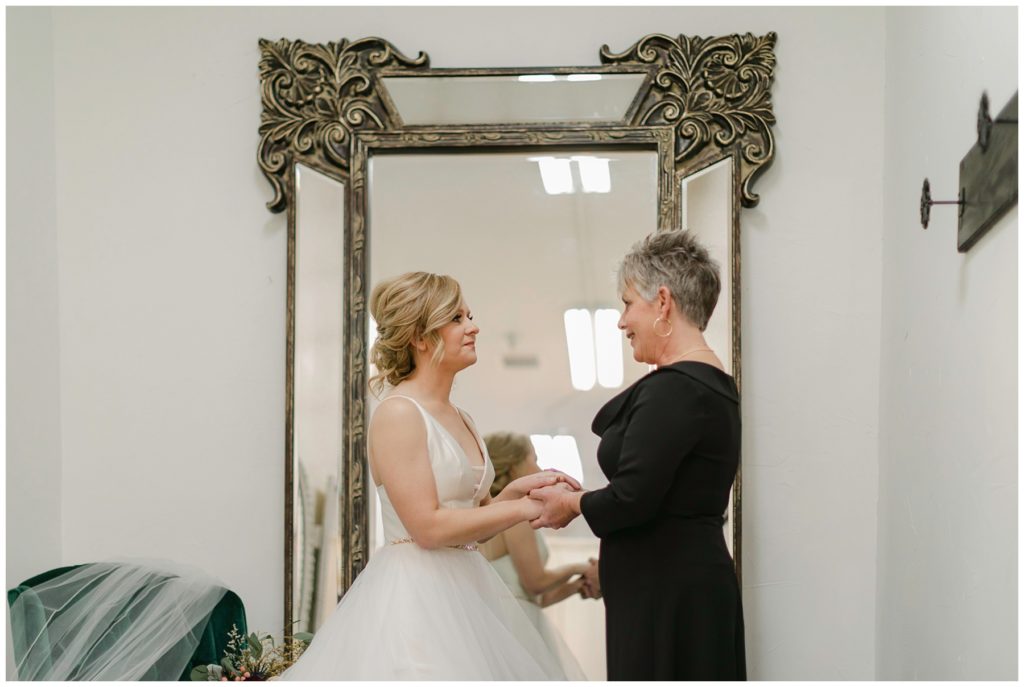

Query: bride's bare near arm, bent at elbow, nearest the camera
<box><xmin>370</xmin><ymin>399</ymin><xmax>541</xmax><ymax>549</ymax></box>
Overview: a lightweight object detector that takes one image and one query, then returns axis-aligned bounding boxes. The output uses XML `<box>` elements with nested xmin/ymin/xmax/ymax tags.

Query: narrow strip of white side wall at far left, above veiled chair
<box><xmin>6</xmin><ymin>7</ymin><xmax>61</xmax><ymax>589</ymax></box>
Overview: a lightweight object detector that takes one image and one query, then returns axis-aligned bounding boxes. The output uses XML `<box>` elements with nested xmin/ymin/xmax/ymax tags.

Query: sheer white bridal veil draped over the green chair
<box><xmin>10</xmin><ymin>560</ymin><xmax>227</xmax><ymax>681</ymax></box>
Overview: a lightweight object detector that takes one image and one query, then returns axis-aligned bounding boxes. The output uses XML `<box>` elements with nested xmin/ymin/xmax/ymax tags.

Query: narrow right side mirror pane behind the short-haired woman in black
<box><xmin>680</xmin><ymin>158</ymin><xmax>735</xmax><ymax>554</ymax></box>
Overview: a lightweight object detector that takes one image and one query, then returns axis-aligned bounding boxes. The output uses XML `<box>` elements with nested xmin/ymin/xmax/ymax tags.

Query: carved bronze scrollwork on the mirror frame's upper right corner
<box><xmin>601</xmin><ymin>32</ymin><xmax>776</xmax><ymax>208</ymax></box>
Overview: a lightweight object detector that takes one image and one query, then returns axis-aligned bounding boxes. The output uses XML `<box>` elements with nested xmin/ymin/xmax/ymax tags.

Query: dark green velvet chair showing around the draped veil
<box><xmin>7</xmin><ymin>565</ymin><xmax>248</xmax><ymax>680</ymax></box>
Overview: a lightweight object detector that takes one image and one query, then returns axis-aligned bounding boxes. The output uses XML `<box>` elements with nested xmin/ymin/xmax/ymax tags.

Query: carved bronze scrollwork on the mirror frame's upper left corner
<box><xmin>259</xmin><ymin>38</ymin><xmax>430</xmax><ymax>212</ymax></box>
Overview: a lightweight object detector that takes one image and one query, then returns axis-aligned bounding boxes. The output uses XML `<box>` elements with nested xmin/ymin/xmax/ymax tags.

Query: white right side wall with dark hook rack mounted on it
<box><xmin>877</xmin><ymin>7</ymin><xmax>1018</xmax><ymax>680</ymax></box>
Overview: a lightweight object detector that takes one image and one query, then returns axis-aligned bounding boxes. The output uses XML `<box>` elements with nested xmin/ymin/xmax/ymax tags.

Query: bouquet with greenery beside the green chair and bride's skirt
<box><xmin>191</xmin><ymin>626</ymin><xmax>313</xmax><ymax>682</ymax></box>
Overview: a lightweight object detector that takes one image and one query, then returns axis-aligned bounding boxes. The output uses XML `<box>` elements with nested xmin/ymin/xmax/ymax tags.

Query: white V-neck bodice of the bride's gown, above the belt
<box><xmin>377</xmin><ymin>394</ymin><xmax>495</xmax><ymax>543</ymax></box>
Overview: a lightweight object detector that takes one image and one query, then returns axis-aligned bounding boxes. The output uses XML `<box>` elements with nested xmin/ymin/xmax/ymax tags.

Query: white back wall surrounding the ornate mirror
<box><xmin>8</xmin><ymin>7</ymin><xmax>885</xmax><ymax>679</ymax></box>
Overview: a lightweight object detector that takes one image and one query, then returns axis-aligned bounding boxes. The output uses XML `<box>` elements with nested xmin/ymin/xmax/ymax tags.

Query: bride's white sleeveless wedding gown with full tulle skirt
<box><xmin>282</xmin><ymin>394</ymin><xmax>582</xmax><ymax>680</ymax></box>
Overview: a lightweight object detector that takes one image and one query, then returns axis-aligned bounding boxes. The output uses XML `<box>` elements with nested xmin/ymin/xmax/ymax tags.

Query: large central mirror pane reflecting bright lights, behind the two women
<box><xmin>367</xmin><ymin>148</ymin><xmax>657</xmax><ymax>680</ymax></box>
